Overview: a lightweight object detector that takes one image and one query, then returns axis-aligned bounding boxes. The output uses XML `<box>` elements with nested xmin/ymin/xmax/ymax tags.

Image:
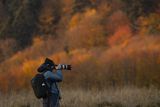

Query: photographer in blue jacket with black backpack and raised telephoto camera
<box><xmin>31</xmin><ymin>58</ymin><xmax>72</xmax><ymax>107</ymax></box>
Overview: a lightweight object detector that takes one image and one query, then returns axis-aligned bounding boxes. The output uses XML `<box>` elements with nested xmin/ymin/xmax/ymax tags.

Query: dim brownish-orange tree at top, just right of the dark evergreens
<box><xmin>37</xmin><ymin>0</ymin><xmax>62</xmax><ymax>35</ymax></box>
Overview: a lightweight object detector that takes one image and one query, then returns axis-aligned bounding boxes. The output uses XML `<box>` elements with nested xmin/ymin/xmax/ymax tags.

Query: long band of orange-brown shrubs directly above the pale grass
<box><xmin>0</xmin><ymin>37</ymin><xmax>160</xmax><ymax>91</ymax></box>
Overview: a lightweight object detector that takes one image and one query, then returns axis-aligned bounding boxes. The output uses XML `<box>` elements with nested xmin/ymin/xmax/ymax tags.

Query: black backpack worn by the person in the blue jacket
<box><xmin>31</xmin><ymin>73</ymin><xmax>50</xmax><ymax>99</ymax></box>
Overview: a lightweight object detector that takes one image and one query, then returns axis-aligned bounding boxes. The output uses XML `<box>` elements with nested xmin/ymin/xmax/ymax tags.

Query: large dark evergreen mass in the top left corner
<box><xmin>0</xmin><ymin>0</ymin><xmax>41</xmax><ymax>48</ymax></box>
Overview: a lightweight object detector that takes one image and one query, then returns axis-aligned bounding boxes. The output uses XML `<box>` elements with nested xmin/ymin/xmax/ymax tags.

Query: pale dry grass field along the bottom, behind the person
<box><xmin>0</xmin><ymin>88</ymin><xmax>160</xmax><ymax>107</ymax></box>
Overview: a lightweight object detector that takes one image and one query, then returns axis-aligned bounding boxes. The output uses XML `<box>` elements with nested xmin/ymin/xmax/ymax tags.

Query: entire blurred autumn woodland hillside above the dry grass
<box><xmin>0</xmin><ymin>0</ymin><xmax>160</xmax><ymax>93</ymax></box>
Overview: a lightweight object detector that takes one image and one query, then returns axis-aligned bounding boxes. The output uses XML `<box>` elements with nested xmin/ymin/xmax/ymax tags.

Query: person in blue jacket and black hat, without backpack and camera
<box><xmin>39</xmin><ymin>58</ymin><xmax>63</xmax><ymax>107</ymax></box>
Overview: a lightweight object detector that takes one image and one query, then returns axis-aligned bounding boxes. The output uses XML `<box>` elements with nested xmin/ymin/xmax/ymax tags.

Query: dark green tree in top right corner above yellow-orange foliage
<box><xmin>122</xmin><ymin>0</ymin><xmax>160</xmax><ymax>29</ymax></box>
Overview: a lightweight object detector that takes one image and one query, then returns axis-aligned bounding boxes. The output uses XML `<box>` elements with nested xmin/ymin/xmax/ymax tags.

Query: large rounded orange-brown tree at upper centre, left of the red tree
<box><xmin>66</xmin><ymin>9</ymin><xmax>105</xmax><ymax>48</ymax></box>
